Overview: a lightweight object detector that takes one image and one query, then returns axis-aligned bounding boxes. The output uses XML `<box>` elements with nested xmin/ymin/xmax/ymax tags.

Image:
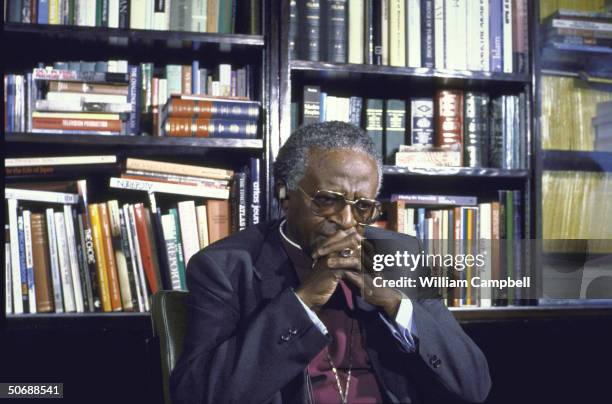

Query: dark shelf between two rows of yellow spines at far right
<box><xmin>542</xmin><ymin>150</ymin><xmax>612</xmax><ymax>173</ymax></box>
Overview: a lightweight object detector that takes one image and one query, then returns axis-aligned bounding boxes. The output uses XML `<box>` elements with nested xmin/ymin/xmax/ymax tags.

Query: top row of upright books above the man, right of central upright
<box><xmin>289</xmin><ymin>0</ymin><xmax>529</xmax><ymax>73</ymax></box>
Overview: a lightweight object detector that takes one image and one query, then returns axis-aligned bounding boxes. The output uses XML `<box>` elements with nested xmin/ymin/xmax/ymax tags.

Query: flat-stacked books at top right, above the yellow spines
<box><xmin>541</xmin><ymin>9</ymin><xmax>612</xmax><ymax>53</ymax></box>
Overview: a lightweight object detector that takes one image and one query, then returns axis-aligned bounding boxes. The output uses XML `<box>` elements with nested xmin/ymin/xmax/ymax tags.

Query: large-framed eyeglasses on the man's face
<box><xmin>297</xmin><ymin>186</ymin><xmax>381</xmax><ymax>225</ymax></box>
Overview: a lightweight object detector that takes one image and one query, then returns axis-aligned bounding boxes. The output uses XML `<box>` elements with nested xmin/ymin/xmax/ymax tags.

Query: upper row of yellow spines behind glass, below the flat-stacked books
<box><xmin>540</xmin><ymin>76</ymin><xmax>612</xmax><ymax>151</ymax></box>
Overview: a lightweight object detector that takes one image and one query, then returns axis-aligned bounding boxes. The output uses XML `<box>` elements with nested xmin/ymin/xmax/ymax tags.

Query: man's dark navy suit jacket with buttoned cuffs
<box><xmin>170</xmin><ymin>221</ymin><xmax>491</xmax><ymax>404</ymax></box>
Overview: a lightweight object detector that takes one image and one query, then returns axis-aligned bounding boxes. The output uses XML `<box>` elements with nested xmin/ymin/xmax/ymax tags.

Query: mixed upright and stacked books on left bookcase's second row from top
<box><xmin>4</xmin><ymin>61</ymin><xmax>259</xmax><ymax>137</ymax></box>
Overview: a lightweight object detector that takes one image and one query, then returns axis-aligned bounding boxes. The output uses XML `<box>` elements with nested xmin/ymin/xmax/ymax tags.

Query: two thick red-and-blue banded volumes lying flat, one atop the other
<box><xmin>160</xmin><ymin>95</ymin><xmax>259</xmax><ymax>139</ymax></box>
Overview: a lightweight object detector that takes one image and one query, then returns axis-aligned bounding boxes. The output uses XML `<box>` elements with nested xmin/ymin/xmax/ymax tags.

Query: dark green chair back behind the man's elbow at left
<box><xmin>151</xmin><ymin>290</ymin><xmax>187</xmax><ymax>404</ymax></box>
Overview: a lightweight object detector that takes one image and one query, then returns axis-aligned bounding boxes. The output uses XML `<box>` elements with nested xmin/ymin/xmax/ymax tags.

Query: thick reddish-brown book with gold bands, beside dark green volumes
<box><xmin>436</xmin><ymin>90</ymin><xmax>463</xmax><ymax>159</ymax></box>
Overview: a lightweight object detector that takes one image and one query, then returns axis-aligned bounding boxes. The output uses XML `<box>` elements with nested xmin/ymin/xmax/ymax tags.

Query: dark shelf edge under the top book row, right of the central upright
<box><xmin>290</xmin><ymin>60</ymin><xmax>531</xmax><ymax>85</ymax></box>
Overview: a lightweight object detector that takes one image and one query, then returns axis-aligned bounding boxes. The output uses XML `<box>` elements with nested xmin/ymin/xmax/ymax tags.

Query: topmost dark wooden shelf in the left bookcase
<box><xmin>4</xmin><ymin>22</ymin><xmax>264</xmax><ymax>47</ymax></box>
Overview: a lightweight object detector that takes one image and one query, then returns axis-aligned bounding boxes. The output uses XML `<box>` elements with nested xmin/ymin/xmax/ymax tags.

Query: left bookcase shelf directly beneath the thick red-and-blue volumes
<box><xmin>4</xmin><ymin>133</ymin><xmax>263</xmax><ymax>153</ymax></box>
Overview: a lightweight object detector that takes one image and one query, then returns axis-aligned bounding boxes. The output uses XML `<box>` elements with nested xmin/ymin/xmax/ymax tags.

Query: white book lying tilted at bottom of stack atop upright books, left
<box><xmin>110</xmin><ymin>177</ymin><xmax>229</xmax><ymax>199</ymax></box>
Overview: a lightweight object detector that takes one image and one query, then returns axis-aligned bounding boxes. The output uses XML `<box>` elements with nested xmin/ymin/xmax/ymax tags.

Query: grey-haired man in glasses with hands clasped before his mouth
<box><xmin>171</xmin><ymin>122</ymin><xmax>491</xmax><ymax>404</ymax></box>
